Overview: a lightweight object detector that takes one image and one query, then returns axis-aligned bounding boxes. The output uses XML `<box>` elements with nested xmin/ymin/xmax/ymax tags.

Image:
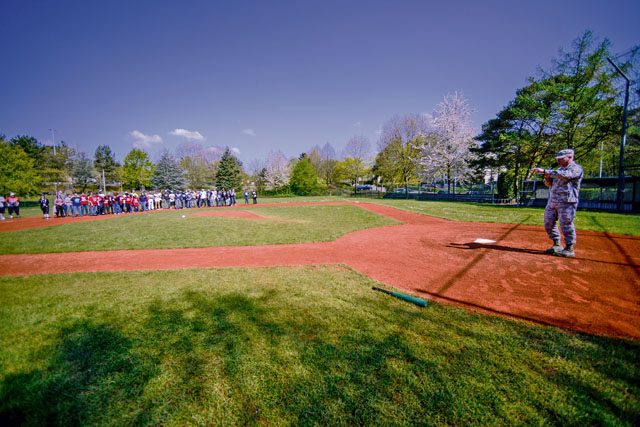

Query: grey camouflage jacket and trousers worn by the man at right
<box><xmin>544</xmin><ymin>162</ymin><xmax>583</xmax><ymax>245</ymax></box>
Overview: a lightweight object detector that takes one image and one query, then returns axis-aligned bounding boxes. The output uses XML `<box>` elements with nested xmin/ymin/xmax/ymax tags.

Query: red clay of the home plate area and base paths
<box><xmin>0</xmin><ymin>203</ymin><xmax>640</xmax><ymax>339</ymax></box>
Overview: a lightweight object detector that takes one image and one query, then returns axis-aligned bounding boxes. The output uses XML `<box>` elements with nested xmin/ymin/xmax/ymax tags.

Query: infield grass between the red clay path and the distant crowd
<box><xmin>0</xmin><ymin>205</ymin><xmax>398</xmax><ymax>254</ymax></box>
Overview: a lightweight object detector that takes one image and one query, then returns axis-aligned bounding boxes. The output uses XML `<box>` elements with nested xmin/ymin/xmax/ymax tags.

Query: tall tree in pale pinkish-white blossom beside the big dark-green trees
<box><xmin>420</xmin><ymin>92</ymin><xmax>476</xmax><ymax>193</ymax></box>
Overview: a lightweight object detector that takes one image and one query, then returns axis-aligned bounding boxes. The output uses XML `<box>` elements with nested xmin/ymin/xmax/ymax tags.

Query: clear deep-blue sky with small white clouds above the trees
<box><xmin>0</xmin><ymin>0</ymin><xmax>640</xmax><ymax>163</ymax></box>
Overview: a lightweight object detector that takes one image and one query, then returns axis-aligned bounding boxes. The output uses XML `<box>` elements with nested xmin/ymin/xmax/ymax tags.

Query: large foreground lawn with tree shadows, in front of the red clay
<box><xmin>0</xmin><ymin>267</ymin><xmax>640</xmax><ymax>426</ymax></box>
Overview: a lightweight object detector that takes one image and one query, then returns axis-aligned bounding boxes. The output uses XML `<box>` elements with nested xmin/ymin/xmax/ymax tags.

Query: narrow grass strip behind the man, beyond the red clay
<box><xmin>371</xmin><ymin>199</ymin><xmax>640</xmax><ymax>236</ymax></box>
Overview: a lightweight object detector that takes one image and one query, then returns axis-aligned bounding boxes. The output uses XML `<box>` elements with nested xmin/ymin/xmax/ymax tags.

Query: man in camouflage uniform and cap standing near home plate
<box><xmin>533</xmin><ymin>149</ymin><xmax>583</xmax><ymax>257</ymax></box>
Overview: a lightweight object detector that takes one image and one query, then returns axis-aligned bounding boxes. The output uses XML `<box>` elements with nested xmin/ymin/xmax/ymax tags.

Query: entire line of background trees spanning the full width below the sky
<box><xmin>0</xmin><ymin>31</ymin><xmax>640</xmax><ymax>198</ymax></box>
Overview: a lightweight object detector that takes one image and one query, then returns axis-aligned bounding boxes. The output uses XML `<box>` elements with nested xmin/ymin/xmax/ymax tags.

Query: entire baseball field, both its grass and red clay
<box><xmin>0</xmin><ymin>199</ymin><xmax>640</xmax><ymax>425</ymax></box>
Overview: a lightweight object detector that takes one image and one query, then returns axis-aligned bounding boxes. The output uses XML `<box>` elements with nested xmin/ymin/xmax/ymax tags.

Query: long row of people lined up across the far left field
<box><xmin>0</xmin><ymin>188</ymin><xmax>258</xmax><ymax>220</ymax></box>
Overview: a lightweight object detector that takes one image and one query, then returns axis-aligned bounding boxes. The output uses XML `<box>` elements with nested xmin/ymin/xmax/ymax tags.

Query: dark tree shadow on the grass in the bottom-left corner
<box><xmin>0</xmin><ymin>320</ymin><xmax>155</xmax><ymax>426</ymax></box>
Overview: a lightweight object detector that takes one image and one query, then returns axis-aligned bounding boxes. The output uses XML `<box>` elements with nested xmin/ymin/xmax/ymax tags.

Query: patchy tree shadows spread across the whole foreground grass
<box><xmin>0</xmin><ymin>291</ymin><xmax>640</xmax><ymax>425</ymax></box>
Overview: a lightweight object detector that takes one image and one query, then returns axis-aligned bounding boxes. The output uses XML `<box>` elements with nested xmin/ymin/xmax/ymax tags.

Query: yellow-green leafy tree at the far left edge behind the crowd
<box><xmin>0</xmin><ymin>138</ymin><xmax>40</xmax><ymax>196</ymax></box>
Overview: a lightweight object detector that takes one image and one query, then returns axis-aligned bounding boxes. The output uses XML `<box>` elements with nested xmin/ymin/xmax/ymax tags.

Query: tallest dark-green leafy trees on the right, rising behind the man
<box><xmin>475</xmin><ymin>31</ymin><xmax>638</xmax><ymax>196</ymax></box>
